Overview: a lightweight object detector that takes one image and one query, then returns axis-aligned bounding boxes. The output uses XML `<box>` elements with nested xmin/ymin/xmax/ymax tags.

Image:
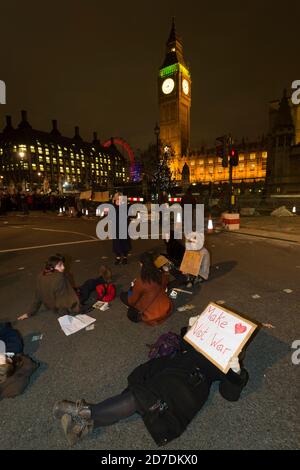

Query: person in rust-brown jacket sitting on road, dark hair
<box><xmin>120</xmin><ymin>253</ymin><xmax>172</xmax><ymax>326</ymax></box>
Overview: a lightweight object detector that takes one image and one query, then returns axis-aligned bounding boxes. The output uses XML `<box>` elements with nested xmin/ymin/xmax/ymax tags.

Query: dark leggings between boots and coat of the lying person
<box><xmin>90</xmin><ymin>389</ymin><xmax>138</xmax><ymax>428</ymax></box>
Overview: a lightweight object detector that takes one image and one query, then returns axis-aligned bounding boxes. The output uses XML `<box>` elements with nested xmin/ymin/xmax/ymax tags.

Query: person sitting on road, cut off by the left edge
<box><xmin>0</xmin><ymin>322</ymin><xmax>38</xmax><ymax>400</ymax></box>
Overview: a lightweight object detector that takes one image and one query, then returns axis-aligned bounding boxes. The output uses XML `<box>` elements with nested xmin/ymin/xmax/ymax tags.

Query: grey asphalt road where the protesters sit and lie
<box><xmin>0</xmin><ymin>214</ymin><xmax>300</xmax><ymax>450</ymax></box>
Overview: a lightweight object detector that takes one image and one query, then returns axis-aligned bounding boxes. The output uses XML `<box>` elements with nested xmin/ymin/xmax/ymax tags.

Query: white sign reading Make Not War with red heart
<box><xmin>184</xmin><ymin>303</ymin><xmax>257</xmax><ymax>374</ymax></box>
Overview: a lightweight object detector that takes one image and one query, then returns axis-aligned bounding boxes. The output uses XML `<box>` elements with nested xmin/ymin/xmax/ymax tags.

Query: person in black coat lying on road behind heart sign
<box><xmin>53</xmin><ymin>322</ymin><xmax>248</xmax><ymax>446</ymax></box>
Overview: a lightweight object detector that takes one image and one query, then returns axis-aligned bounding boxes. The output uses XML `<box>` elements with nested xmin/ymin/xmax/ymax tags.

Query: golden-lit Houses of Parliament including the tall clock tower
<box><xmin>158</xmin><ymin>19</ymin><xmax>300</xmax><ymax>194</ymax></box>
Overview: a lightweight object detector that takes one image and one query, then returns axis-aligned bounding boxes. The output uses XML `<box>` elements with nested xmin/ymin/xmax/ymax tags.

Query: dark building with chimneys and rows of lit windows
<box><xmin>0</xmin><ymin>111</ymin><xmax>129</xmax><ymax>189</ymax></box>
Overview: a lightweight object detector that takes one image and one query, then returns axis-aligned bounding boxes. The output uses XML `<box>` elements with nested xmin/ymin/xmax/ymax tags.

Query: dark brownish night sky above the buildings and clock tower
<box><xmin>0</xmin><ymin>0</ymin><xmax>300</xmax><ymax>149</ymax></box>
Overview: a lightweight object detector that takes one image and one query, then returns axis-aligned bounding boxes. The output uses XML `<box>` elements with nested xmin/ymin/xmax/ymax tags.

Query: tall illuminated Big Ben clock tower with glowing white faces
<box><xmin>158</xmin><ymin>18</ymin><xmax>191</xmax><ymax>179</ymax></box>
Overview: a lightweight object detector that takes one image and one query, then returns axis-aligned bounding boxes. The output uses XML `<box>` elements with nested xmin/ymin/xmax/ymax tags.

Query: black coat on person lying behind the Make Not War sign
<box><xmin>128</xmin><ymin>345</ymin><xmax>248</xmax><ymax>446</ymax></box>
